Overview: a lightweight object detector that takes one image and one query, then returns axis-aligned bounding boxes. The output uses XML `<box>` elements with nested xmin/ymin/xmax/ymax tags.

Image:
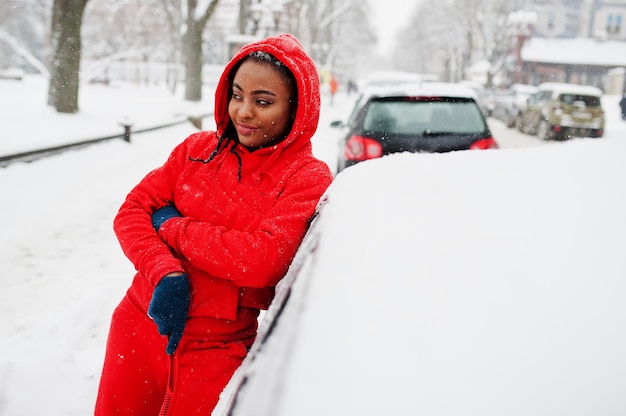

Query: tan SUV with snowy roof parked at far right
<box><xmin>518</xmin><ymin>82</ymin><xmax>605</xmax><ymax>140</ymax></box>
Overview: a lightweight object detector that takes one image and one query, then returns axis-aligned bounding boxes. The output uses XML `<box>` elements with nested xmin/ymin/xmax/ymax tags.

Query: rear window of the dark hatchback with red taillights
<box><xmin>363</xmin><ymin>97</ymin><xmax>486</xmax><ymax>135</ymax></box>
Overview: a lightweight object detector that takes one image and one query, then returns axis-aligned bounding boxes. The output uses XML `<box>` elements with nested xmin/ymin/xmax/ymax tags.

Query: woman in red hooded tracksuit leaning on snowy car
<box><xmin>95</xmin><ymin>35</ymin><xmax>332</xmax><ymax>416</ymax></box>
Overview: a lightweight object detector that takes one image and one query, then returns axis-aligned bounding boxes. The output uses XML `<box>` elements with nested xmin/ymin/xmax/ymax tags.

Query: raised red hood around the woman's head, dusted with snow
<box><xmin>215</xmin><ymin>34</ymin><xmax>320</xmax><ymax>154</ymax></box>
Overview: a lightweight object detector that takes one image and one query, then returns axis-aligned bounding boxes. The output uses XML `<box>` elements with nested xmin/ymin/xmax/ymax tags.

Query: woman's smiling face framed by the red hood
<box><xmin>228</xmin><ymin>59</ymin><xmax>292</xmax><ymax>148</ymax></box>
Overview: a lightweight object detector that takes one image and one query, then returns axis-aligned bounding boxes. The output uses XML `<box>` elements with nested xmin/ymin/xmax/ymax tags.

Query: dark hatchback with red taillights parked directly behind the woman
<box><xmin>331</xmin><ymin>82</ymin><xmax>498</xmax><ymax>173</ymax></box>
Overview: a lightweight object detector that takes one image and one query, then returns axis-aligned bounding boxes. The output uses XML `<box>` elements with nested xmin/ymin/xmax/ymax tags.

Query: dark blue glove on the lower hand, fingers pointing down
<box><xmin>148</xmin><ymin>274</ymin><xmax>191</xmax><ymax>354</ymax></box>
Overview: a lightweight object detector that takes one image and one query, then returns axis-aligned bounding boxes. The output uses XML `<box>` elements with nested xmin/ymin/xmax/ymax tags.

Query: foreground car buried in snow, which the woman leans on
<box><xmin>213</xmin><ymin>145</ymin><xmax>626</xmax><ymax>416</ymax></box>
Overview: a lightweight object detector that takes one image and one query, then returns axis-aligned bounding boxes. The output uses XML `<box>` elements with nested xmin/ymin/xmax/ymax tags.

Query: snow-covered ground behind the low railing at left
<box><xmin>0</xmin><ymin>75</ymin><xmax>213</xmax><ymax>155</ymax></box>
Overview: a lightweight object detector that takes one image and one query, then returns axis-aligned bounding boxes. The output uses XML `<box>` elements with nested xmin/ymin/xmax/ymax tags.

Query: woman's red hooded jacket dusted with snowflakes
<box><xmin>114</xmin><ymin>35</ymin><xmax>332</xmax><ymax>339</ymax></box>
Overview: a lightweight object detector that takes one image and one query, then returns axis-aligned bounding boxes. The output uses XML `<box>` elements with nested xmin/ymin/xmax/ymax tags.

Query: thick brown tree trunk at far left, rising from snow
<box><xmin>48</xmin><ymin>0</ymin><xmax>87</xmax><ymax>113</ymax></box>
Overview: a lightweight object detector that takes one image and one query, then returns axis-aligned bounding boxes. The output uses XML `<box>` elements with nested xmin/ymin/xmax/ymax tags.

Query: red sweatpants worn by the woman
<box><xmin>95</xmin><ymin>297</ymin><xmax>246</xmax><ymax>416</ymax></box>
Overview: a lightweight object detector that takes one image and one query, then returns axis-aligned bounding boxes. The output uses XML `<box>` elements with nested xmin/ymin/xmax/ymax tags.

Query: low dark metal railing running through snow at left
<box><xmin>0</xmin><ymin>113</ymin><xmax>213</xmax><ymax>167</ymax></box>
